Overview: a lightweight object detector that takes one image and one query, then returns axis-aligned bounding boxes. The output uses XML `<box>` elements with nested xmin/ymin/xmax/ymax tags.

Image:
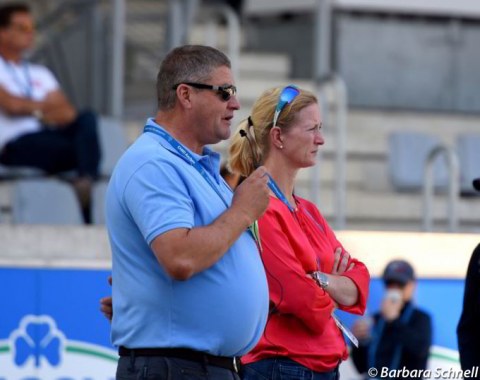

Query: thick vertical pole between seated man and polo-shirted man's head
<box><xmin>110</xmin><ymin>0</ymin><xmax>126</xmax><ymax>118</ymax></box>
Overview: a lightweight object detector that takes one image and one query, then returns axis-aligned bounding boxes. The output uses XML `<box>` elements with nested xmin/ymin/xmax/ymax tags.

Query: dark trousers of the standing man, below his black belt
<box><xmin>116</xmin><ymin>356</ymin><xmax>240</xmax><ymax>380</ymax></box>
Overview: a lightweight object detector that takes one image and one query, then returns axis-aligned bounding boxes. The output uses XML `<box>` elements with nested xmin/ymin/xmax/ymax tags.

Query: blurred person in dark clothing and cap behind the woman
<box><xmin>351</xmin><ymin>260</ymin><xmax>432</xmax><ymax>379</ymax></box>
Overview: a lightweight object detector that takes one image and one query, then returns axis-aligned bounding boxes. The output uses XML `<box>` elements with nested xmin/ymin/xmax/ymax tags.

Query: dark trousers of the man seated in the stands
<box><xmin>0</xmin><ymin>111</ymin><xmax>100</xmax><ymax>178</ymax></box>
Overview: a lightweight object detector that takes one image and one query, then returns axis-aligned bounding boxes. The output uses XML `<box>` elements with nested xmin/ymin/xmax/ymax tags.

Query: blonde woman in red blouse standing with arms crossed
<box><xmin>230</xmin><ymin>86</ymin><xmax>370</xmax><ymax>380</ymax></box>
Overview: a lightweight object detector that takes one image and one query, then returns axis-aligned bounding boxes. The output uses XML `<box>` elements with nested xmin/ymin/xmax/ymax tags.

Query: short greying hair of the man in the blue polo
<box><xmin>157</xmin><ymin>45</ymin><xmax>231</xmax><ymax>111</ymax></box>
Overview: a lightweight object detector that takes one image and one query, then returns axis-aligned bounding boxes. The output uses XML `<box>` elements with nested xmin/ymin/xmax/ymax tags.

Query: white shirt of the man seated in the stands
<box><xmin>0</xmin><ymin>58</ymin><xmax>59</xmax><ymax>149</ymax></box>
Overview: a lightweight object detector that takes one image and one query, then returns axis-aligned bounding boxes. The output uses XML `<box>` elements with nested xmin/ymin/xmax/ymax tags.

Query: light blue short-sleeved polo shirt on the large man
<box><xmin>106</xmin><ymin>119</ymin><xmax>268</xmax><ymax>356</ymax></box>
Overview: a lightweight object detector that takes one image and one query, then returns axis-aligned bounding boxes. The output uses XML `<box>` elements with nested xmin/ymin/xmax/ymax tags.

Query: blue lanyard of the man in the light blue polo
<box><xmin>143</xmin><ymin>124</ymin><xmax>262</xmax><ymax>250</ymax></box>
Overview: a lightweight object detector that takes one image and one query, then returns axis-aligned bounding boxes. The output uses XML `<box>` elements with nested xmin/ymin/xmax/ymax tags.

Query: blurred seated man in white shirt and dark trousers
<box><xmin>0</xmin><ymin>3</ymin><xmax>100</xmax><ymax>221</ymax></box>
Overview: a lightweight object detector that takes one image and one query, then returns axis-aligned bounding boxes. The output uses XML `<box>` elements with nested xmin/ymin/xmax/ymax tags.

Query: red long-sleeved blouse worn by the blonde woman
<box><xmin>242</xmin><ymin>197</ymin><xmax>370</xmax><ymax>372</ymax></box>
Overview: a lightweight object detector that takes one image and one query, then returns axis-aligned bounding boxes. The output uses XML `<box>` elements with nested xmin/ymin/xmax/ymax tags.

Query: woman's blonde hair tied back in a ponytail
<box><xmin>228</xmin><ymin>87</ymin><xmax>318</xmax><ymax>177</ymax></box>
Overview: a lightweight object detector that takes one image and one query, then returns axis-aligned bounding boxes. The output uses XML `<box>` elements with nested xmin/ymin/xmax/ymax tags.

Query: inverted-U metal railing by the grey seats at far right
<box><xmin>423</xmin><ymin>145</ymin><xmax>460</xmax><ymax>232</ymax></box>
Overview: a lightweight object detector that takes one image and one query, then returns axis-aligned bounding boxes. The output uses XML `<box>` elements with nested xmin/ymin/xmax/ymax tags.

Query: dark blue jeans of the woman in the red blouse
<box><xmin>242</xmin><ymin>358</ymin><xmax>340</xmax><ymax>380</ymax></box>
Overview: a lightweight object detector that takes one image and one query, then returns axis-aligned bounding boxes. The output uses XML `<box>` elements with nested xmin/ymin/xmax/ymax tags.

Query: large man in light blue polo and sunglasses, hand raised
<box><xmin>106</xmin><ymin>46</ymin><xmax>269</xmax><ymax>379</ymax></box>
